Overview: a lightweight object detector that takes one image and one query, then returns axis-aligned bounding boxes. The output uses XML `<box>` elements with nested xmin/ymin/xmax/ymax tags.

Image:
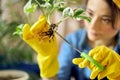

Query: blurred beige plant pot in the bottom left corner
<box><xmin>0</xmin><ymin>70</ymin><xmax>29</xmax><ymax>80</ymax></box>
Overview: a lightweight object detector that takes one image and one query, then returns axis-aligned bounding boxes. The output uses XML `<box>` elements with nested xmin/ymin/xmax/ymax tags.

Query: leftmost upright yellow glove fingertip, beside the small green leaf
<box><xmin>22</xmin><ymin>24</ymin><xmax>32</xmax><ymax>40</ymax></box>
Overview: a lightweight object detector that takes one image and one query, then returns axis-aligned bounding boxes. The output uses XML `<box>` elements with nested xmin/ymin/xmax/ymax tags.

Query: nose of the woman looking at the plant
<box><xmin>89</xmin><ymin>17</ymin><xmax>101</xmax><ymax>30</ymax></box>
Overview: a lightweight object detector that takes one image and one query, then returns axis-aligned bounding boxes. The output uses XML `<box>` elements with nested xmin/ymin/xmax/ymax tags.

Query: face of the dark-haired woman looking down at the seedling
<box><xmin>85</xmin><ymin>0</ymin><xmax>120</xmax><ymax>41</ymax></box>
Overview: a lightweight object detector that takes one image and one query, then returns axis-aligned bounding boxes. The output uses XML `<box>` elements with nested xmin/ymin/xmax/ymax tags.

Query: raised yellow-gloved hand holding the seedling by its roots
<box><xmin>22</xmin><ymin>15</ymin><xmax>59</xmax><ymax>78</ymax></box>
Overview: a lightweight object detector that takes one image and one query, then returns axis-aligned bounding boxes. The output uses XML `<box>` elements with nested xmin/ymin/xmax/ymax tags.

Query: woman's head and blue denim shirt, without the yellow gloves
<box><xmin>59</xmin><ymin>0</ymin><xmax>120</xmax><ymax>80</ymax></box>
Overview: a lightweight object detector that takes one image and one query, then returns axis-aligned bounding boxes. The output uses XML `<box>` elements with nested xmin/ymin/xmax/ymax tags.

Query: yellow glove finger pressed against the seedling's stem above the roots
<box><xmin>30</xmin><ymin>15</ymin><xmax>48</xmax><ymax>34</ymax></box>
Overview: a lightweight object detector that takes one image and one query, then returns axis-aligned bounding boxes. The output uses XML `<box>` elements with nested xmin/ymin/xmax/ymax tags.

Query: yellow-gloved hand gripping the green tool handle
<box><xmin>73</xmin><ymin>46</ymin><xmax>120</xmax><ymax>80</ymax></box>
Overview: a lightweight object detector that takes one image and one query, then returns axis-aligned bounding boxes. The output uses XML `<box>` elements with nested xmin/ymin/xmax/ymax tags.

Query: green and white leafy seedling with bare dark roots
<box><xmin>14</xmin><ymin>0</ymin><xmax>90</xmax><ymax>39</ymax></box>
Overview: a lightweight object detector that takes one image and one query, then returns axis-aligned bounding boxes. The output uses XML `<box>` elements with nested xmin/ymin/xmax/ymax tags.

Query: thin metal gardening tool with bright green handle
<box><xmin>54</xmin><ymin>30</ymin><xmax>104</xmax><ymax>71</ymax></box>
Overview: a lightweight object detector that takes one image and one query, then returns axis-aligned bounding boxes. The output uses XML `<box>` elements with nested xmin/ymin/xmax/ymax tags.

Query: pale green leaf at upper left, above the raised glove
<box><xmin>24</xmin><ymin>0</ymin><xmax>37</xmax><ymax>15</ymax></box>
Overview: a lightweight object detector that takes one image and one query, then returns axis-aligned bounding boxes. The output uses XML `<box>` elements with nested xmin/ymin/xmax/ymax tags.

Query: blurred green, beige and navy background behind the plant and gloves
<box><xmin>0</xmin><ymin>0</ymin><xmax>85</xmax><ymax>80</ymax></box>
